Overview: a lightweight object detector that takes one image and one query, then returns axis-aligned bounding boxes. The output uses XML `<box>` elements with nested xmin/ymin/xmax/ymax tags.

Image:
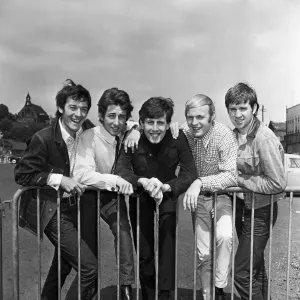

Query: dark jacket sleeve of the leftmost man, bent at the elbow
<box><xmin>14</xmin><ymin>134</ymin><xmax>58</xmax><ymax>186</ymax></box>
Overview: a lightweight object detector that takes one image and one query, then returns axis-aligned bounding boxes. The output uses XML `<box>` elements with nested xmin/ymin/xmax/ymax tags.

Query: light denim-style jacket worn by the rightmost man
<box><xmin>235</xmin><ymin>117</ymin><xmax>286</xmax><ymax>208</ymax></box>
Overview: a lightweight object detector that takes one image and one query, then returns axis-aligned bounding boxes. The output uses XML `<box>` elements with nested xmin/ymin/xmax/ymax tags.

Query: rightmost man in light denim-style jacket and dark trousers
<box><xmin>225</xmin><ymin>83</ymin><xmax>286</xmax><ymax>300</ymax></box>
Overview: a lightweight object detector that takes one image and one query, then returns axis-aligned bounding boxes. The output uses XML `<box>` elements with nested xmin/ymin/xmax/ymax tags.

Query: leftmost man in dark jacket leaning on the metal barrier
<box><xmin>15</xmin><ymin>80</ymin><xmax>97</xmax><ymax>300</ymax></box>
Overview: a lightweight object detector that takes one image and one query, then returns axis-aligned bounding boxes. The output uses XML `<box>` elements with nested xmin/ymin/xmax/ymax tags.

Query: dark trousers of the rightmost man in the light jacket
<box><xmin>234</xmin><ymin>200</ymin><xmax>278</xmax><ymax>300</ymax></box>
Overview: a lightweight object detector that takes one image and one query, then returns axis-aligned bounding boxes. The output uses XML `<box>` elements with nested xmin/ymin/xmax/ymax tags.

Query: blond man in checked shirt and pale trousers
<box><xmin>183</xmin><ymin>94</ymin><xmax>237</xmax><ymax>300</ymax></box>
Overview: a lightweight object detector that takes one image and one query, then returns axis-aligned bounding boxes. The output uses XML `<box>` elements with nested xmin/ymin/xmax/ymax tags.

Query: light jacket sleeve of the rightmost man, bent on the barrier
<box><xmin>238</xmin><ymin>139</ymin><xmax>286</xmax><ymax>194</ymax></box>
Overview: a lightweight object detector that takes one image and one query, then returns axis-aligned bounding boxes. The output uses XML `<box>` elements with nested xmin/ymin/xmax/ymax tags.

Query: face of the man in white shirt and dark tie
<box><xmin>100</xmin><ymin>104</ymin><xmax>126</xmax><ymax>136</ymax></box>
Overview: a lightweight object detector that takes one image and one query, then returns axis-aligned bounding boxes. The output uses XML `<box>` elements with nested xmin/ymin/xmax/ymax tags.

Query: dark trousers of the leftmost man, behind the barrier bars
<box><xmin>42</xmin><ymin>205</ymin><xmax>97</xmax><ymax>300</ymax></box>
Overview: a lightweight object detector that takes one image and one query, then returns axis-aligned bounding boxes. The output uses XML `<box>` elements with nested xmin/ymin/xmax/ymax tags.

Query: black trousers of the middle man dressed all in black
<box><xmin>129</xmin><ymin>197</ymin><xmax>176</xmax><ymax>300</ymax></box>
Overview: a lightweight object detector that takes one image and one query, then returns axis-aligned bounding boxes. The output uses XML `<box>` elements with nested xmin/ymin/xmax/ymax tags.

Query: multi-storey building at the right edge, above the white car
<box><xmin>286</xmin><ymin>104</ymin><xmax>300</xmax><ymax>154</ymax></box>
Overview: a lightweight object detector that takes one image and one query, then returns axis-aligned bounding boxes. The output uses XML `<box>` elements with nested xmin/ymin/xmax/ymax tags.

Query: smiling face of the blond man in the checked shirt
<box><xmin>186</xmin><ymin>105</ymin><xmax>215</xmax><ymax>138</ymax></box>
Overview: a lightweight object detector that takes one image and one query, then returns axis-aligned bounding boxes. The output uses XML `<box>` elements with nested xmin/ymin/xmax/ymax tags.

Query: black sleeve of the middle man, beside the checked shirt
<box><xmin>166</xmin><ymin>130</ymin><xmax>197</xmax><ymax>198</ymax></box>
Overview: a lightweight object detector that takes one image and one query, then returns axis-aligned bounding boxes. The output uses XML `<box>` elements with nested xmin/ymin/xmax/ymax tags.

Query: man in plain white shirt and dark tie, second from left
<box><xmin>74</xmin><ymin>88</ymin><xmax>140</xmax><ymax>300</ymax></box>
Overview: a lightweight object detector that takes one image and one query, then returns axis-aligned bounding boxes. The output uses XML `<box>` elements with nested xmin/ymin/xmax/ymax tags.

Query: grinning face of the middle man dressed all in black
<box><xmin>141</xmin><ymin>114</ymin><xmax>170</xmax><ymax>144</ymax></box>
